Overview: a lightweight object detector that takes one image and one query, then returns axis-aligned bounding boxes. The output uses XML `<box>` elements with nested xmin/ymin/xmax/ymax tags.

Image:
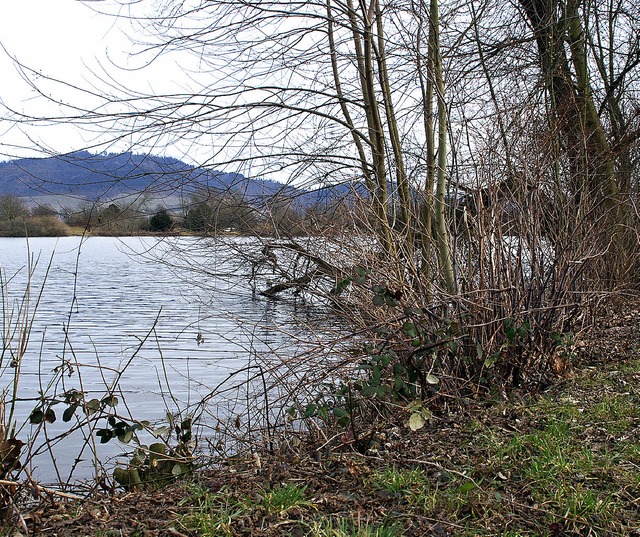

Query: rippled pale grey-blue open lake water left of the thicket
<box><xmin>0</xmin><ymin>237</ymin><xmax>310</xmax><ymax>481</ymax></box>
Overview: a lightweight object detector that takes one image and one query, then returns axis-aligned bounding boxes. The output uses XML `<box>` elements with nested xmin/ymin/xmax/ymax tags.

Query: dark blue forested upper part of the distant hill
<box><xmin>0</xmin><ymin>151</ymin><xmax>295</xmax><ymax>200</ymax></box>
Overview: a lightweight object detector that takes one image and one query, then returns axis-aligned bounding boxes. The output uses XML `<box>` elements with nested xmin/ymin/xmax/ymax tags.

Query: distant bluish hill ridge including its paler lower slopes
<box><xmin>0</xmin><ymin>151</ymin><xmax>364</xmax><ymax>216</ymax></box>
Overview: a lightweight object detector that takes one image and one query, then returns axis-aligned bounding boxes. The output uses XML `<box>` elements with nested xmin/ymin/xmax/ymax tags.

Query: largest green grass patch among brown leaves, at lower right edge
<box><xmin>460</xmin><ymin>361</ymin><xmax>640</xmax><ymax>531</ymax></box>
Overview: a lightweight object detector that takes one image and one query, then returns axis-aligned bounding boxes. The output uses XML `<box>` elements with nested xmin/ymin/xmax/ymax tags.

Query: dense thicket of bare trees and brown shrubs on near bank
<box><xmin>141</xmin><ymin>0</ymin><xmax>640</xmax><ymax>460</ymax></box>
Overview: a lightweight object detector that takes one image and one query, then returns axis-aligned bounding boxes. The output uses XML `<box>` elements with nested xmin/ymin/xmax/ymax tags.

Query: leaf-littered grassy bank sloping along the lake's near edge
<box><xmin>6</xmin><ymin>302</ymin><xmax>640</xmax><ymax>537</ymax></box>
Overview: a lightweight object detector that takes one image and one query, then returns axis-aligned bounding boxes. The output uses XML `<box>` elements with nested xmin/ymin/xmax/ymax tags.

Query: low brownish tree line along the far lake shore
<box><xmin>0</xmin><ymin>191</ymin><xmax>361</xmax><ymax>237</ymax></box>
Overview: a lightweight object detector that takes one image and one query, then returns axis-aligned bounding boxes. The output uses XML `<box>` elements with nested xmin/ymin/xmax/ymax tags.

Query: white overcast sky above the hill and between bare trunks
<box><xmin>0</xmin><ymin>0</ymin><xmax>638</xmax><ymax>191</ymax></box>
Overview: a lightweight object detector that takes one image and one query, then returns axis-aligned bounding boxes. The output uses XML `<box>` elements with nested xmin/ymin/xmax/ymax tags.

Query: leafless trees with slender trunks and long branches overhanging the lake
<box><xmin>0</xmin><ymin>0</ymin><xmax>640</xmax><ymax>390</ymax></box>
